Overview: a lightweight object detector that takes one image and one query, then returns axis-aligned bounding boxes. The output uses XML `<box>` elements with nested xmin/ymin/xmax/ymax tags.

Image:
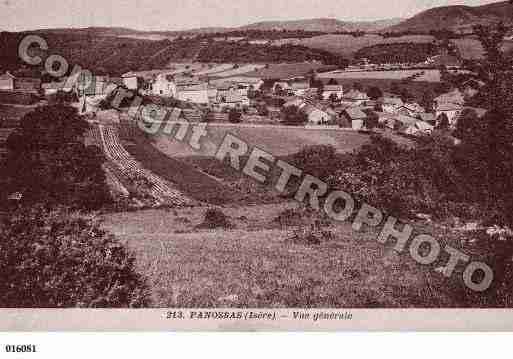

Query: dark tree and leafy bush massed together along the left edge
<box><xmin>0</xmin><ymin>105</ymin><xmax>149</xmax><ymax>308</ymax></box>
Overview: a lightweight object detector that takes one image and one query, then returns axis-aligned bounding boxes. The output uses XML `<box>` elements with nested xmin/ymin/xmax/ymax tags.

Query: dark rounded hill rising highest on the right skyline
<box><xmin>386</xmin><ymin>1</ymin><xmax>513</xmax><ymax>33</ymax></box>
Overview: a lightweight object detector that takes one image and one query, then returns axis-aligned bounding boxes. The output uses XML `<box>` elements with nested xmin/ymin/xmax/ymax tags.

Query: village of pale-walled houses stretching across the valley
<box><xmin>0</xmin><ymin>59</ymin><xmax>484</xmax><ymax>142</ymax></box>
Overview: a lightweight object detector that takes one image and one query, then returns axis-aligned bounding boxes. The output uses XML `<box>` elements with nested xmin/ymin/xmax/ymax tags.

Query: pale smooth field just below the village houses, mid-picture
<box><xmin>150</xmin><ymin>124</ymin><xmax>368</xmax><ymax>158</ymax></box>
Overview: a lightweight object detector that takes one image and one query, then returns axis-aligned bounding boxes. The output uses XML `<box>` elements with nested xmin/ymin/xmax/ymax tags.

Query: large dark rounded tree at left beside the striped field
<box><xmin>1</xmin><ymin>105</ymin><xmax>111</xmax><ymax>210</ymax></box>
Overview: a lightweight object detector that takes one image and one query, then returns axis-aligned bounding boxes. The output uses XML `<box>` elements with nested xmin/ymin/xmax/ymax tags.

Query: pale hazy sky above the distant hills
<box><xmin>0</xmin><ymin>0</ymin><xmax>504</xmax><ymax>31</ymax></box>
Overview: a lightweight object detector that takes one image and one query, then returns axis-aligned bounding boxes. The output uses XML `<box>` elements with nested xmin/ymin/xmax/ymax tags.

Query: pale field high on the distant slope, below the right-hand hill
<box><xmin>276</xmin><ymin>34</ymin><xmax>435</xmax><ymax>58</ymax></box>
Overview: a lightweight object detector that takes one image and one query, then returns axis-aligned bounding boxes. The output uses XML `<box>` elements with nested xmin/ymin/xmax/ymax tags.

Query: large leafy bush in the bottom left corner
<box><xmin>0</xmin><ymin>208</ymin><xmax>149</xmax><ymax>308</ymax></box>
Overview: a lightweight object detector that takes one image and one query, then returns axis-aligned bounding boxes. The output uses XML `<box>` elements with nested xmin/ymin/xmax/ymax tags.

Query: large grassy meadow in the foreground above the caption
<box><xmin>104</xmin><ymin>203</ymin><xmax>488</xmax><ymax>308</ymax></box>
